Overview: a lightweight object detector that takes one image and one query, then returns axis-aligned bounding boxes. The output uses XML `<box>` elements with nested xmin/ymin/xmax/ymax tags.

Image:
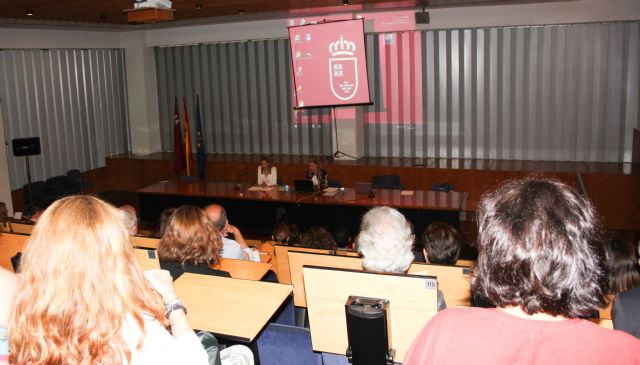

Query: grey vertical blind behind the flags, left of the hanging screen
<box><xmin>155</xmin><ymin>39</ymin><xmax>332</xmax><ymax>155</ymax></box>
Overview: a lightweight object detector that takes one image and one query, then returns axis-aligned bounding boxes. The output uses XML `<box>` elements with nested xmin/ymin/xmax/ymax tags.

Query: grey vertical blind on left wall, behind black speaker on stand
<box><xmin>0</xmin><ymin>49</ymin><xmax>130</xmax><ymax>189</ymax></box>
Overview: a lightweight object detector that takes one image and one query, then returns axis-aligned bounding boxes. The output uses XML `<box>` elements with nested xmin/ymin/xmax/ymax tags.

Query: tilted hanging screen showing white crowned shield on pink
<box><xmin>289</xmin><ymin>19</ymin><xmax>371</xmax><ymax>108</ymax></box>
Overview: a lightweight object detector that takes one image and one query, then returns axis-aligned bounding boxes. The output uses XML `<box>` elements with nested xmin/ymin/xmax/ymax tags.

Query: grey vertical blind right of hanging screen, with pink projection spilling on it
<box><xmin>364</xmin><ymin>22</ymin><xmax>640</xmax><ymax>162</ymax></box>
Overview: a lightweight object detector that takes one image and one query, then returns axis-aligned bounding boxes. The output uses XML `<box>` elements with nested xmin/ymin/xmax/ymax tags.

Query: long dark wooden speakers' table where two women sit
<box><xmin>138</xmin><ymin>181</ymin><xmax>468</xmax><ymax>234</ymax></box>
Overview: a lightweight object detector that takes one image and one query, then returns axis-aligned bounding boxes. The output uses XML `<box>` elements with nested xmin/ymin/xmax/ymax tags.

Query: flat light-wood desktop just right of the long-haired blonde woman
<box><xmin>175</xmin><ymin>273</ymin><xmax>292</xmax><ymax>343</ymax></box>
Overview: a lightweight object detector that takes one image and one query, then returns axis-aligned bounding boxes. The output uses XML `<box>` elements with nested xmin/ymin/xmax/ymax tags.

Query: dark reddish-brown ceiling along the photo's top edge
<box><xmin>0</xmin><ymin>0</ymin><xmax>566</xmax><ymax>27</ymax></box>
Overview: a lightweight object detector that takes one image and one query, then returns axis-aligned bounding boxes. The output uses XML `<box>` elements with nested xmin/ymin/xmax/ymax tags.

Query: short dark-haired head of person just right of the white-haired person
<box><xmin>422</xmin><ymin>222</ymin><xmax>461</xmax><ymax>265</ymax></box>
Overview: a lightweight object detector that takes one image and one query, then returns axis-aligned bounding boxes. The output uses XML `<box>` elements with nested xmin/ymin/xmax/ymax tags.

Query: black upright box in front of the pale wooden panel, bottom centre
<box><xmin>345</xmin><ymin>296</ymin><xmax>395</xmax><ymax>365</ymax></box>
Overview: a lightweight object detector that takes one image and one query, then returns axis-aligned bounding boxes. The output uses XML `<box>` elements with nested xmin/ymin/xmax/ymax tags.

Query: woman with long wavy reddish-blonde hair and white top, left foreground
<box><xmin>9</xmin><ymin>196</ymin><xmax>208</xmax><ymax>365</ymax></box>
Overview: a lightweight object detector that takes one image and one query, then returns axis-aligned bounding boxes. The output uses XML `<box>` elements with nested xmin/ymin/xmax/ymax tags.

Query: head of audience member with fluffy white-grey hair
<box><xmin>356</xmin><ymin>207</ymin><xmax>413</xmax><ymax>273</ymax></box>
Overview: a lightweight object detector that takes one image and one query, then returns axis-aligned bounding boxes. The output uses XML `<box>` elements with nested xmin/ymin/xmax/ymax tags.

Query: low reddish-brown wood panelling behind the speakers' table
<box><xmin>88</xmin><ymin>153</ymin><xmax>640</xmax><ymax>231</ymax></box>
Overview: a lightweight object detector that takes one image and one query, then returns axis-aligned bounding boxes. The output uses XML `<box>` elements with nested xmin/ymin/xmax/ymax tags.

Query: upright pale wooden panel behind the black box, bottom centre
<box><xmin>302</xmin><ymin>266</ymin><xmax>438</xmax><ymax>362</ymax></box>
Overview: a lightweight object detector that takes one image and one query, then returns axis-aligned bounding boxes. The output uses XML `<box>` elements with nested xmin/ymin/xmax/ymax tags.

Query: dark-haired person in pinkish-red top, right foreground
<box><xmin>404</xmin><ymin>178</ymin><xmax>640</xmax><ymax>365</ymax></box>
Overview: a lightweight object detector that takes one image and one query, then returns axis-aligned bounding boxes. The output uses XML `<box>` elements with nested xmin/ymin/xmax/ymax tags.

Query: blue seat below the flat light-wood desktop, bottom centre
<box><xmin>257</xmin><ymin>323</ymin><xmax>322</xmax><ymax>365</ymax></box>
